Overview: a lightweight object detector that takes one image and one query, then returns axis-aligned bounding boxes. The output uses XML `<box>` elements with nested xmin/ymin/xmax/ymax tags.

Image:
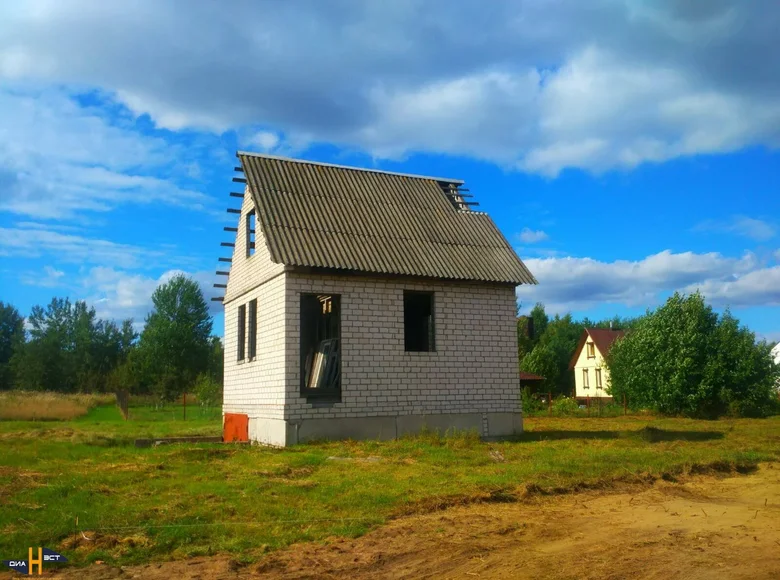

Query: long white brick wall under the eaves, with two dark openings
<box><xmin>285</xmin><ymin>274</ymin><xmax>520</xmax><ymax>420</ymax></box>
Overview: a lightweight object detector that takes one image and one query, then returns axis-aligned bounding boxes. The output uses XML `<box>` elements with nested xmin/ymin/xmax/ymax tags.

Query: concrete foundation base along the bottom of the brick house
<box><xmin>249</xmin><ymin>413</ymin><xmax>523</xmax><ymax>447</ymax></box>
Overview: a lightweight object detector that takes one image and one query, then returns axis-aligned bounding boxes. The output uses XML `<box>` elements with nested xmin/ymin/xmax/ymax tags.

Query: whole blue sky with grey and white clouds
<box><xmin>0</xmin><ymin>0</ymin><xmax>780</xmax><ymax>340</ymax></box>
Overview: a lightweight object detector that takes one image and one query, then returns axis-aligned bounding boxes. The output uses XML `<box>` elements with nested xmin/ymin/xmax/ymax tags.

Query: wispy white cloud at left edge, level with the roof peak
<box><xmin>0</xmin><ymin>86</ymin><xmax>216</xmax><ymax>219</ymax></box>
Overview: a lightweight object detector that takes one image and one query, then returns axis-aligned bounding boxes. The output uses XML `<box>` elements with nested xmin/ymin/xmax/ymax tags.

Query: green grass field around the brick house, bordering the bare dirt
<box><xmin>0</xmin><ymin>406</ymin><xmax>780</xmax><ymax>564</ymax></box>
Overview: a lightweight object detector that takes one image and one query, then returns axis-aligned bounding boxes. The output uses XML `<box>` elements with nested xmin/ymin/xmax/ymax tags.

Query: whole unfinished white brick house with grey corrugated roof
<box><xmin>223</xmin><ymin>153</ymin><xmax>536</xmax><ymax>445</ymax></box>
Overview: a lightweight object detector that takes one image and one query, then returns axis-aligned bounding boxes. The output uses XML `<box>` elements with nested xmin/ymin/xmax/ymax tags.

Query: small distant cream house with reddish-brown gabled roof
<box><xmin>569</xmin><ymin>328</ymin><xmax>625</xmax><ymax>399</ymax></box>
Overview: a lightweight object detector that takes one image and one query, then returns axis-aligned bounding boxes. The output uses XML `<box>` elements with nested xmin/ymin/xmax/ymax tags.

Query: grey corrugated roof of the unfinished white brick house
<box><xmin>238</xmin><ymin>152</ymin><xmax>536</xmax><ymax>284</ymax></box>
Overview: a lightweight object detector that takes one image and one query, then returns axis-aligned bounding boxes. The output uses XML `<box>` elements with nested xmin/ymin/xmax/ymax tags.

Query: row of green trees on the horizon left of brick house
<box><xmin>0</xmin><ymin>275</ymin><xmax>223</xmax><ymax>400</ymax></box>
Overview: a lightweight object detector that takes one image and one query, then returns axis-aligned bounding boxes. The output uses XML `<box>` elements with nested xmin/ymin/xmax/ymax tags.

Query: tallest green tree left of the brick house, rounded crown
<box><xmin>138</xmin><ymin>275</ymin><xmax>212</xmax><ymax>400</ymax></box>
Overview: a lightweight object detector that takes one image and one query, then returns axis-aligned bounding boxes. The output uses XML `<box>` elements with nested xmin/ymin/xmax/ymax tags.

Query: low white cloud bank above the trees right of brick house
<box><xmin>517</xmin><ymin>250</ymin><xmax>768</xmax><ymax>312</ymax></box>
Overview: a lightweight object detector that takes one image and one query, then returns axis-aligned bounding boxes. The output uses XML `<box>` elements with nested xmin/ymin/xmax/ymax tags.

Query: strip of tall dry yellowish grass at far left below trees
<box><xmin>0</xmin><ymin>391</ymin><xmax>114</xmax><ymax>421</ymax></box>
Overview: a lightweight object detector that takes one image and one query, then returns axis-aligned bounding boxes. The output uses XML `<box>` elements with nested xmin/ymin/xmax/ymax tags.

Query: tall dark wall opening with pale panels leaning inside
<box><xmin>300</xmin><ymin>294</ymin><xmax>341</xmax><ymax>399</ymax></box>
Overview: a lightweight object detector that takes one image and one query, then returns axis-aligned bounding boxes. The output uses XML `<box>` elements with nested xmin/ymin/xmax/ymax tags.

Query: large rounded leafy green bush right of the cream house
<box><xmin>607</xmin><ymin>292</ymin><xmax>778</xmax><ymax>417</ymax></box>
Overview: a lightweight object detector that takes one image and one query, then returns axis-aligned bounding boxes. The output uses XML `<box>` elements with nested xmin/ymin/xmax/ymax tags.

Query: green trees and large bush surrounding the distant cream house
<box><xmin>517</xmin><ymin>292</ymin><xmax>780</xmax><ymax>418</ymax></box>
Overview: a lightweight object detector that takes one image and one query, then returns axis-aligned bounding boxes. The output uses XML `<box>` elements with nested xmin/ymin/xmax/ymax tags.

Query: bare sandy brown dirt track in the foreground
<box><xmin>29</xmin><ymin>464</ymin><xmax>780</xmax><ymax>580</ymax></box>
